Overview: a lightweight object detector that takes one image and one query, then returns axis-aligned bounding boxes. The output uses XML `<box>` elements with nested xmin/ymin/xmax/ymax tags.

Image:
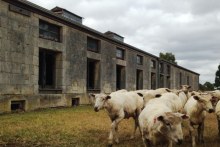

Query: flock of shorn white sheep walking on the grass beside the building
<box><xmin>89</xmin><ymin>85</ymin><xmax>220</xmax><ymax>147</ymax></box>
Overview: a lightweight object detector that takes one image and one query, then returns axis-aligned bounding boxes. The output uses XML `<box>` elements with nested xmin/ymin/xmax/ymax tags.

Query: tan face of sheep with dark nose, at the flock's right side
<box><xmin>193</xmin><ymin>94</ymin><xmax>214</xmax><ymax>113</ymax></box>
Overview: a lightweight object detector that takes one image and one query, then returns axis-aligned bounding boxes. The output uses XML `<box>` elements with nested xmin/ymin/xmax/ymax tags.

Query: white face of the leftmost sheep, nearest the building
<box><xmin>90</xmin><ymin>93</ymin><xmax>111</xmax><ymax>112</ymax></box>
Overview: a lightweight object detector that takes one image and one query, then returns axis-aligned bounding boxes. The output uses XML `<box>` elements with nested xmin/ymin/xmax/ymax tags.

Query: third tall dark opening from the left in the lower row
<box><xmin>116</xmin><ymin>65</ymin><xmax>125</xmax><ymax>90</ymax></box>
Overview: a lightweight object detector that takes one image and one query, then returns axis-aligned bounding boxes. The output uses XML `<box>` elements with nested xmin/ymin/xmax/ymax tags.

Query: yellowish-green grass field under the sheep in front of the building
<box><xmin>0</xmin><ymin>106</ymin><xmax>220</xmax><ymax>147</ymax></box>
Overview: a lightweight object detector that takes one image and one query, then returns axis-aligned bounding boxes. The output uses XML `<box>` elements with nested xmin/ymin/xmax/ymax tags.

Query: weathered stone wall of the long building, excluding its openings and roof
<box><xmin>0</xmin><ymin>0</ymin><xmax>199</xmax><ymax>113</ymax></box>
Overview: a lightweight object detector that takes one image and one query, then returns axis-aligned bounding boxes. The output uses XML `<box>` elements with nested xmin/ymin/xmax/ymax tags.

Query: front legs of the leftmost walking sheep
<box><xmin>108</xmin><ymin>113</ymin><xmax>124</xmax><ymax>146</ymax></box>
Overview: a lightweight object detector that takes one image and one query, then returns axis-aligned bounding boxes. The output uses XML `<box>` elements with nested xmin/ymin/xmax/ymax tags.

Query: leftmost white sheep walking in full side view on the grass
<box><xmin>90</xmin><ymin>92</ymin><xmax>143</xmax><ymax>146</ymax></box>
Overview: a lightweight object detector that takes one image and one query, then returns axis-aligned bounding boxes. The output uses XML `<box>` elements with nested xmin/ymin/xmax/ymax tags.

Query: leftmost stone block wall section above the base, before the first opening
<box><xmin>0</xmin><ymin>1</ymin><xmax>36</xmax><ymax>94</ymax></box>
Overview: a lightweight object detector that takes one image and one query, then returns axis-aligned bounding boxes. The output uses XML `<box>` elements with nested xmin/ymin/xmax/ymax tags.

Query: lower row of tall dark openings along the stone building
<box><xmin>39</xmin><ymin>49</ymin><xmax>186</xmax><ymax>90</ymax></box>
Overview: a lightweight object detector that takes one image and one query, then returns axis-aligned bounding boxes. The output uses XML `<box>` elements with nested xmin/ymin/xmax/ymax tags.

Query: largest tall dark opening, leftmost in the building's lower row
<box><xmin>39</xmin><ymin>49</ymin><xmax>55</xmax><ymax>89</ymax></box>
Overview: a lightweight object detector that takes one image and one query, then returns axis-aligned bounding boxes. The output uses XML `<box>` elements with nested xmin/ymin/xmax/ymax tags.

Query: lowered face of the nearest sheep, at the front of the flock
<box><xmin>157</xmin><ymin>112</ymin><xmax>189</xmax><ymax>144</ymax></box>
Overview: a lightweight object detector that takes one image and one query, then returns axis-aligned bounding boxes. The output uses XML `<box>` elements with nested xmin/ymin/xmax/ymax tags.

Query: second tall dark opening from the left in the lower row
<box><xmin>87</xmin><ymin>59</ymin><xmax>100</xmax><ymax>90</ymax></box>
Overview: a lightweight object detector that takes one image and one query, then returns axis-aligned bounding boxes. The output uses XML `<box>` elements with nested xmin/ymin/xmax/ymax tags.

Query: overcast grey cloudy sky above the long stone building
<box><xmin>29</xmin><ymin>0</ymin><xmax>220</xmax><ymax>84</ymax></box>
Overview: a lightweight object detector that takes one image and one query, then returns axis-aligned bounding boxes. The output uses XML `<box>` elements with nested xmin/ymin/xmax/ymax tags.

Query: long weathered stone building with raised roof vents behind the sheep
<box><xmin>0</xmin><ymin>0</ymin><xmax>199</xmax><ymax>113</ymax></box>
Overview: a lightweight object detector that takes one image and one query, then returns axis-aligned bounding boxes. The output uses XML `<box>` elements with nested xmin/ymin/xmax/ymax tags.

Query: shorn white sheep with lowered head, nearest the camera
<box><xmin>139</xmin><ymin>98</ymin><xmax>188</xmax><ymax>147</ymax></box>
